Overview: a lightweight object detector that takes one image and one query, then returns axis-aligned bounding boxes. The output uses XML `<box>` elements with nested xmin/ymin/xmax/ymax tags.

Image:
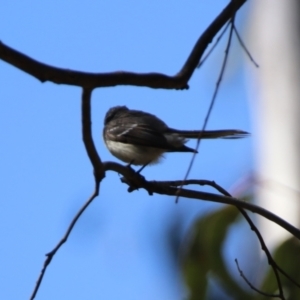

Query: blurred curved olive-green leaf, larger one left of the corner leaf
<box><xmin>183</xmin><ymin>206</ymin><xmax>253</xmax><ymax>300</ymax></box>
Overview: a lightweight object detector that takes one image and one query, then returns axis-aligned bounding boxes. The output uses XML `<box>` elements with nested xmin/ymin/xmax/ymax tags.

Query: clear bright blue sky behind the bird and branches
<box><xmin>0</xmin><ymin>0</ymin><xmax>253</xmax><ymax>300</ymax></box>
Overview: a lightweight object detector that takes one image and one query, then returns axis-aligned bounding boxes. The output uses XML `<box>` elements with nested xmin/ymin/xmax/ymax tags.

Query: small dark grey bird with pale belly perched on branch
<box><xmin>103</xmin><ymin>106</ymin><xmax>249</xmax><ymax>168</ymax></box>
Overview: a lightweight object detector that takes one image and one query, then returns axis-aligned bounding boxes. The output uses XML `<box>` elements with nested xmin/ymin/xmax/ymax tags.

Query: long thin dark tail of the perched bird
<box><xmin>169</xmin><ymin>128</ymin><xmax>249</xmax><ymax>139</ymax></box>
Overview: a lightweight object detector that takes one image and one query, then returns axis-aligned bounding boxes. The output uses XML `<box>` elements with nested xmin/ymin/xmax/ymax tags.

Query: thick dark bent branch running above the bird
<box><xmin>0</xmin><ymin>0</ymin><xmax>247</xmax><ymax>89</ymax></box>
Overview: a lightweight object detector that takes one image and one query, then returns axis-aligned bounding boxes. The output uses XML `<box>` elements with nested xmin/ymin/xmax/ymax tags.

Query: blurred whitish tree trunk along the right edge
<box><xmin>248</xmin><ymin>0</ymin><xmax>300</xmax><ymax>248</ymax></box>
